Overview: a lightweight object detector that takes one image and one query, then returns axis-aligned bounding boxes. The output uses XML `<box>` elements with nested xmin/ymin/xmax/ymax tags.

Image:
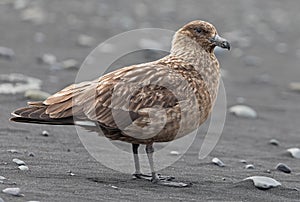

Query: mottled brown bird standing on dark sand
<box><xmin>11</xmin><ymin>20</ymin><xmax>230</xmax><ymax>187</ymax></box>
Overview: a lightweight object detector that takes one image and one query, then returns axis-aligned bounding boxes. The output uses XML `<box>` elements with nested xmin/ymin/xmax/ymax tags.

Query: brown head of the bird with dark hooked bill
<box><xmin>173</xmin><ymin>20</ymin><xmax>230</xmax><ymax>52</ymax></box>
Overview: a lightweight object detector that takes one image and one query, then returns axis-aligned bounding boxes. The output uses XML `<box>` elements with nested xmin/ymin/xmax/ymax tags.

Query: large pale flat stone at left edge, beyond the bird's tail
<box><xmin>0</xmin><ymin>74</ymin><xmax>42</xmax><ymax>95</ymax></box>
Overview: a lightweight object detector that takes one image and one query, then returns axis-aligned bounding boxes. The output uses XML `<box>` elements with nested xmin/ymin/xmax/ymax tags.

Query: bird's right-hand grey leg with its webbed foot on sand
<box><xmin>146</xmin><ymin>144</ymin><xmax>190</xmax><ymax>187</ymax></box>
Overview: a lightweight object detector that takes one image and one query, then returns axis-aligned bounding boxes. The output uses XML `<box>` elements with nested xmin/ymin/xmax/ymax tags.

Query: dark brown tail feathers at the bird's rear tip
<box><xmin>10</xmin><ymin>103</ymin><xmax>74</xmax><ymax>125</ymax></box>
